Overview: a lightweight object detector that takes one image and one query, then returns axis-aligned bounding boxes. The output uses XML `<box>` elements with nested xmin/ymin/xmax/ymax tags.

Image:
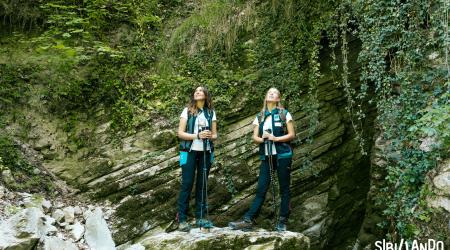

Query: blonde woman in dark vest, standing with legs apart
<box><xmin>229</xmin><ymin>88</ymin><xmax>295</xmax><ymax>232</ymax></box>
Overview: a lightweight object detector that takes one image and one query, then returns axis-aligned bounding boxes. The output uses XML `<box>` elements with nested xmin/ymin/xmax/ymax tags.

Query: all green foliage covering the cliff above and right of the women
<box><xmin>0</xmin><ymin>0</ymin><xmax>450</xmax><ymax>240</ymax></box>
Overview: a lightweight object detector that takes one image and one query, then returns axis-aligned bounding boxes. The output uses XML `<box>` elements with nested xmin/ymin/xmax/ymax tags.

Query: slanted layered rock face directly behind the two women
<box><xmin>5</xmin><ymin>36</ymin><xmax>372</xmax><ymax>248</ymax></box>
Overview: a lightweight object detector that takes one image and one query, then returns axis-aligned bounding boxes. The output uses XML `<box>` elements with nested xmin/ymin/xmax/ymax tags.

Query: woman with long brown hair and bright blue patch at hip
<box><xmin>177</xmin><ymin>87</ymin><xmax>217</xmax><ymax>232</ymax></box>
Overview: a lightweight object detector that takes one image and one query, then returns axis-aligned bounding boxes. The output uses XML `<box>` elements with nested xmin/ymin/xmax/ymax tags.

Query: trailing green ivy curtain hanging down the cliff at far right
<box><xmin>353</xmin><ymin>0</ymin><xmax>449</xmax><ymax>240</ymax></box>
